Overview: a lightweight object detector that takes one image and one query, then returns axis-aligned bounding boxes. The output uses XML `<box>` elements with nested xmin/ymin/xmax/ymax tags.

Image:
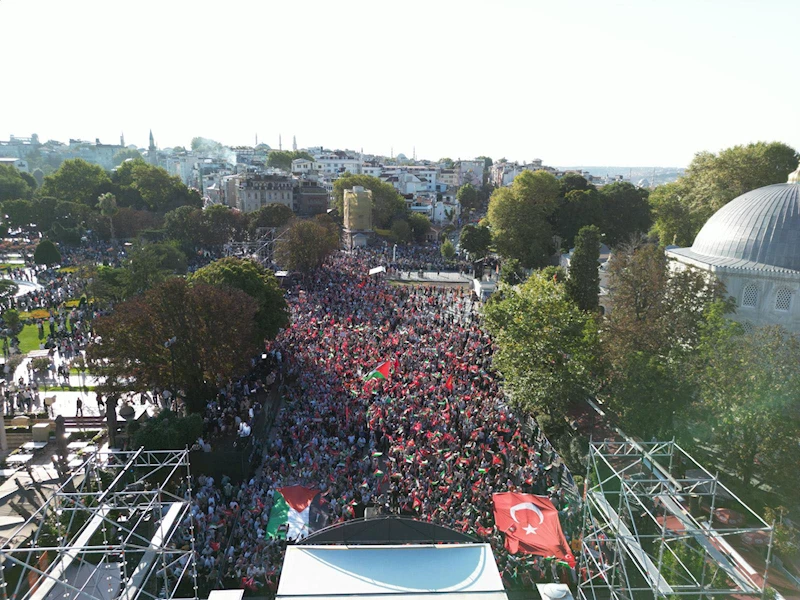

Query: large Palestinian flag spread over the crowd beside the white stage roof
<box><xmin>267</xmin><ymin>485</ymin><xmax>328</xmax><ymax>540</ymax></box>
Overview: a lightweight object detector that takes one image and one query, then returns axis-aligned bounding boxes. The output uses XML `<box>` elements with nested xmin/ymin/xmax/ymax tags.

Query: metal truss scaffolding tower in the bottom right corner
<box><xmin>577</xmin><ymin>431</ymin><xmax>773</xmax><ymax>600</ymax></box>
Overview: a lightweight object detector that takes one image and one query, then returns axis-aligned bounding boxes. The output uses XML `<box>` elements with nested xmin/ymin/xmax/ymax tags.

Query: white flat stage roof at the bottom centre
<box><xmin>276</xmin><ymin>544</ymin><xmax>507</xmax><ymax>600</ymax></box>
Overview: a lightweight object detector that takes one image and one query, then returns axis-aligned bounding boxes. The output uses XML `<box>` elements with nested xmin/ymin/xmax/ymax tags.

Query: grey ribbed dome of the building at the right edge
<box><xmin>691</xmin><ymin>180</ymin><xmax>800</xmax><ymax>271</ymax></box>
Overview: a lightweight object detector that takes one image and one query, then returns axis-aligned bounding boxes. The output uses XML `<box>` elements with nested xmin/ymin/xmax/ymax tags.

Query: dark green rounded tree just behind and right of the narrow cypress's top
<box><xmin>600</xmin><ymin>181</ymin><xmax>650</xmax><ymax>247</ymax></box>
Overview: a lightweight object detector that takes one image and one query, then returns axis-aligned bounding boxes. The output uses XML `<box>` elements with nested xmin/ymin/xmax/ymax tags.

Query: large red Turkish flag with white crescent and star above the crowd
<box><xmin>492</xmin><ymin>492</ymin><xmax>575</xmax><ymax>567</ymax></box>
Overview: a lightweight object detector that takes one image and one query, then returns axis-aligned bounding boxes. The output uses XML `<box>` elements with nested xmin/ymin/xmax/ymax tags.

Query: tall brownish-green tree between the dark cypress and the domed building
<box><xmin>602</xmin><ymin>242</ymin><xmax>732</xmax><ymax>438</ymax></box>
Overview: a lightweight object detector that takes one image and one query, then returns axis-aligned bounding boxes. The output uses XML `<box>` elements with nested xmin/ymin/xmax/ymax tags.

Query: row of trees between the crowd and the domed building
<box><xmin>485</xmin><ymin>239</ymin><xmax>800</xmax><ymax>491</ymax></box>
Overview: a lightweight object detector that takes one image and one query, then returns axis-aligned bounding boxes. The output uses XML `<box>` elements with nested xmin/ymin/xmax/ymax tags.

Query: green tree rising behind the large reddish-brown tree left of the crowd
<box><xmin>189</xmin><ymin>257</ymin><xmax>289</xmax><ymax>339</ymax></box>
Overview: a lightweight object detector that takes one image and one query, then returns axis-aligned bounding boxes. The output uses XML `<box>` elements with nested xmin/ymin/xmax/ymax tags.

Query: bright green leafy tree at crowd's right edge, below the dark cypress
<box><xmin>485</xmin><ymin>273</ymin><xmax>598</xmax><ymax>418</ymax></box>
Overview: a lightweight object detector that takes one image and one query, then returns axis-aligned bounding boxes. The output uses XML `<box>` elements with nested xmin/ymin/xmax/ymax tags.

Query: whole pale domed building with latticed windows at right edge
<box><xmin>667</xmin><ymin>168</ymin><xmax>800</xmax><ymax>333</ymax></box>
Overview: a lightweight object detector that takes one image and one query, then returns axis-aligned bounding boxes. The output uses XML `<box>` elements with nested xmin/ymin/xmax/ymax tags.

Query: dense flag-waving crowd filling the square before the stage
<box><xmin>177</xmin><ymin>251</ymin><xmax>577</xmax><ymax>590</ymax></box>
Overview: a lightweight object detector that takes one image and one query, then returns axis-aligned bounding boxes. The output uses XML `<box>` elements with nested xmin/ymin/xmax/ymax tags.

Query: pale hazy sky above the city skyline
<box><xmin>0</xmin><ymin>0</ymin><xmax>800</xmax><ymax>167</ymax></box>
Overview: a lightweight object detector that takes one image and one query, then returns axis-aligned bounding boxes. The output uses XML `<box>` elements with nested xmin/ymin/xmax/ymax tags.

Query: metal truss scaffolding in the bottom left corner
<box><xmin>0</xmin><ymin>449</ymin><xmax>198</xmax><ymax>600</ymax></box>
